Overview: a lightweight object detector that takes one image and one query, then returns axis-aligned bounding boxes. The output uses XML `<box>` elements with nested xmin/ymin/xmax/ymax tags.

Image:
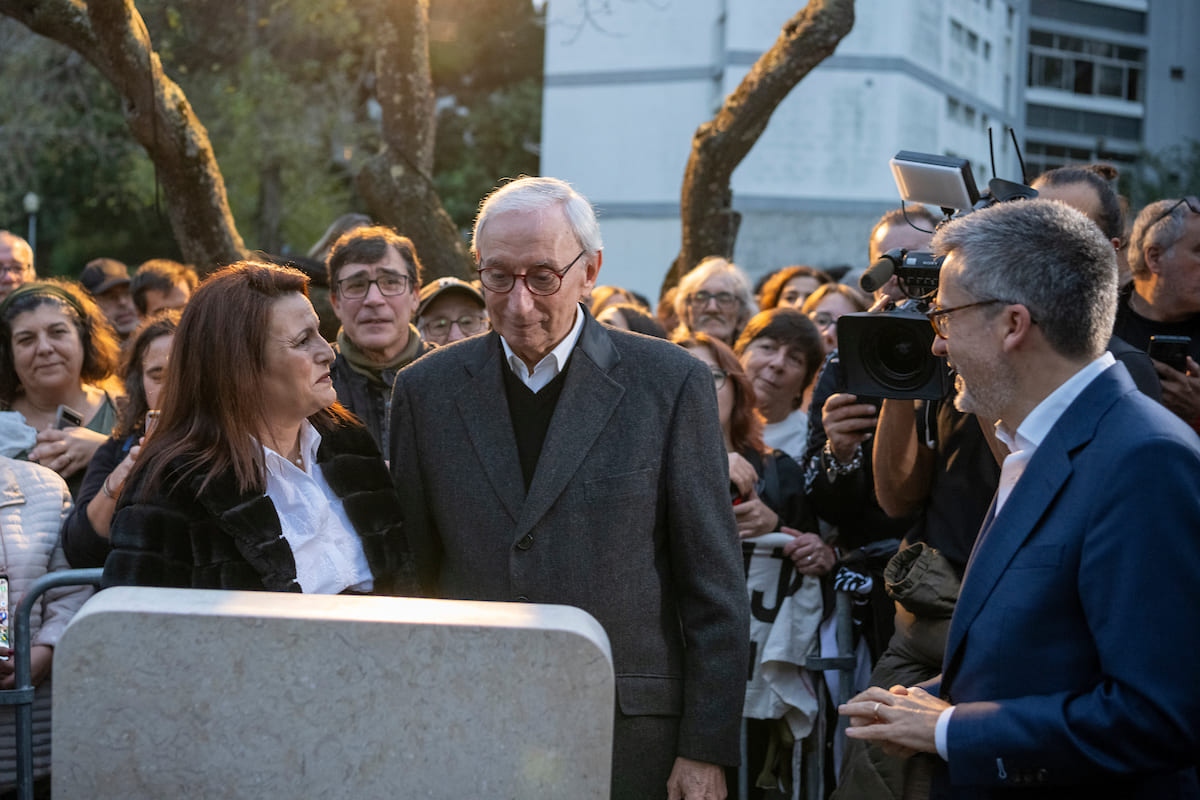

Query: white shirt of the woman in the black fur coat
<box><xmin>263</xmin><ymin>420</ymin><xmax>374</xmax><ymax>595</ymax></box>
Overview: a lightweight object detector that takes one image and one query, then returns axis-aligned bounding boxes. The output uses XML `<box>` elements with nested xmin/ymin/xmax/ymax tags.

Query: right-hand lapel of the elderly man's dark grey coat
<box><xmin>516</xmin><ymin>316</ymin><xmax>625</xmax><ymax>539</ymax></box>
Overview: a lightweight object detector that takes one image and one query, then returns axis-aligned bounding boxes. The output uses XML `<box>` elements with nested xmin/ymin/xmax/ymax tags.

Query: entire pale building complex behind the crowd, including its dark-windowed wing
<box><xmin>541</xmin><ymin>0</ymin><xmax>1200</xmax><ymax>299</ymax></box>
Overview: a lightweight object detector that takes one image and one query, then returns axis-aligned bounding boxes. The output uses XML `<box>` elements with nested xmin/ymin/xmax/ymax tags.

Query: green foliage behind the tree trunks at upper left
<box><xmin>0</xmin><ymin>0</ymin><xmax>544</xmax><ymax>268</ymax></box>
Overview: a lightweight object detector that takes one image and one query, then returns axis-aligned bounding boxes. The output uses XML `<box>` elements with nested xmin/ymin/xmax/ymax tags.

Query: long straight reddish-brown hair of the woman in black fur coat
<box><xmin>131</xmin><ymin>261</ymin><xmax>352</xmax><ymax>497</ymax></box>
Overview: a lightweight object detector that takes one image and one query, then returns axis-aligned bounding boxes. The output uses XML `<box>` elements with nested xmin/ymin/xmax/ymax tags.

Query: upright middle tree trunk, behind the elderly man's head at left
<box><xmin>358</xmin><ymin>0</ymin><xmax>474</xmax><ymax>284</ymax></box>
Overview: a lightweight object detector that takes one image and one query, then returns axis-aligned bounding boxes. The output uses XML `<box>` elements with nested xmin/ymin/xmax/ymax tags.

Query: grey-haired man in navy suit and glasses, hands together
<box><xmin>841</xmin><ymin>200</ymin><xmax>1200</xmax><ymax>800</ymax></box>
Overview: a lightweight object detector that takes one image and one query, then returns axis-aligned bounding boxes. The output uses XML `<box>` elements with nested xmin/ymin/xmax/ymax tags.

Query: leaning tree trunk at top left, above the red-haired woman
<box><xmin>0</xmin><ymin>0</ymin><xmax>247</xmax><ymax>272</ymax></box>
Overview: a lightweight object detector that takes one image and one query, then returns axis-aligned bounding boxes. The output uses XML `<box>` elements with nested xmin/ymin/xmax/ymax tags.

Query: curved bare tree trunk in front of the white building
<box><xmin>662</xmin><ymin>0</ymin><xmax>854</xmax><ymax>290</ymax></box>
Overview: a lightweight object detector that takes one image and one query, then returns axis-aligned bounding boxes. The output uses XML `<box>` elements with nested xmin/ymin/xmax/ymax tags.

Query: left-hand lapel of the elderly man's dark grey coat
<box><xmin>457</xmin><ymin>331</ymin><xmax>525</xmax><ymax>521</ymax></box>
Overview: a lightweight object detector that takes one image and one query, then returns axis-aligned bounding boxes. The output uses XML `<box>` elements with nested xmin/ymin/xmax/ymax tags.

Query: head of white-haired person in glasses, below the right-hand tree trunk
<box><xmin>674</xmin><ymin>255</ymin><xmax>758</xmax><ymax>347</ymax></box>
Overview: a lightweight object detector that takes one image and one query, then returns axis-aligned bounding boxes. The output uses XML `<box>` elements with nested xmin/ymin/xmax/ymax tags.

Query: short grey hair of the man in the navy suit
<box><xmin>932</xmin><ymin>200</ymin><xmax>1117</xmax><ymax>359</ymax></box>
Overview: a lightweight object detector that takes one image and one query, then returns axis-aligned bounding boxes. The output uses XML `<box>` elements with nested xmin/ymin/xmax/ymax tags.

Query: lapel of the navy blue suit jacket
<box><xmin>942</xmin><ymin>368</ymin><xmax>1134</xmax><ymax>691</ymax></box>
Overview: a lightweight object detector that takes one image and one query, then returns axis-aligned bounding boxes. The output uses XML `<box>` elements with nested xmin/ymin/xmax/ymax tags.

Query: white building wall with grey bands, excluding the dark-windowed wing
<box><xmin>541</xmin><ymin>0</ymin><xmax>1026</xmax><ymax>300</ymax></box>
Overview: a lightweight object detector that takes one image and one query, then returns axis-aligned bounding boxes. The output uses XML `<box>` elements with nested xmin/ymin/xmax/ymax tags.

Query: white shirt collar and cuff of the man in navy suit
<box><xmin>934</xmin><ymin>353</ymin><xmax>1116</xmax><ymax>760</ymax></box>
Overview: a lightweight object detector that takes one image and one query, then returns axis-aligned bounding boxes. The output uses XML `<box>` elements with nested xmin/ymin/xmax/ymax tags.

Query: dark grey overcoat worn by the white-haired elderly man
<box><xmin>391</xmin><ymin>307</ymin><xmax>749</xmax><ymax>765</ymax></box>
